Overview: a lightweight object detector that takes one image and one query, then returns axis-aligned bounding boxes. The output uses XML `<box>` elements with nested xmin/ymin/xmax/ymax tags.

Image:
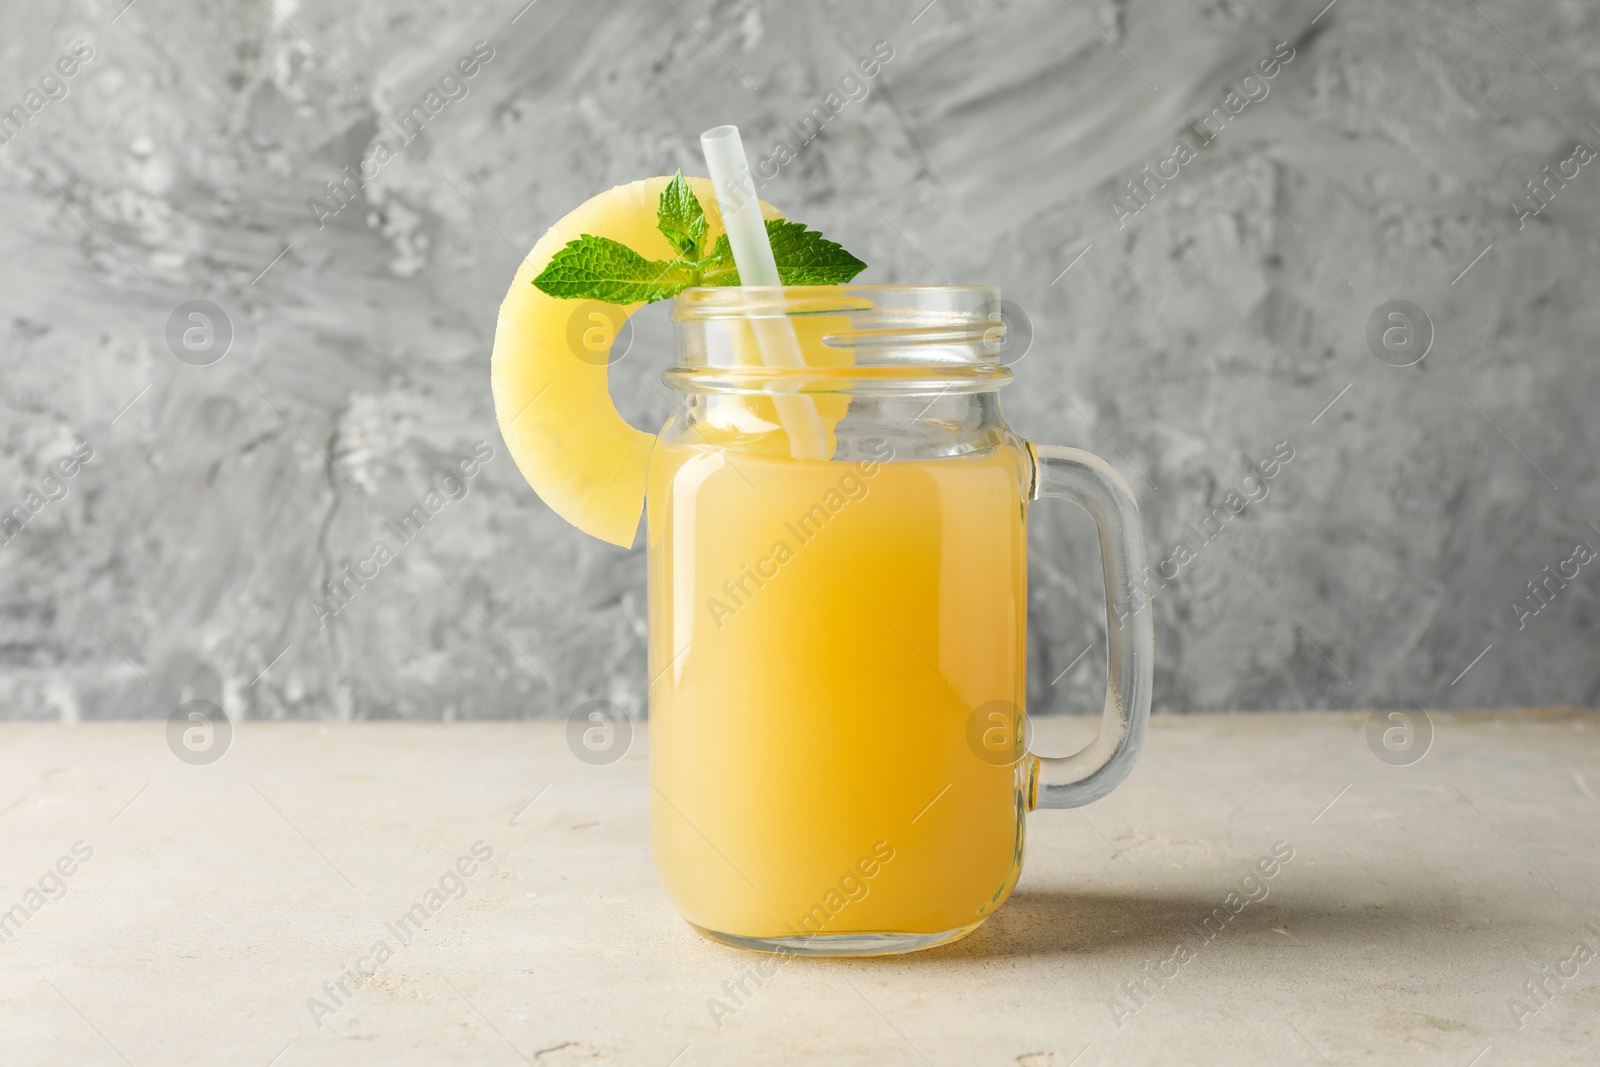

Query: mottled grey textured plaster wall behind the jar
<box><xmin>0</xmin><ymin>0</ymin><xmax>1600</xmax><ymax>720</ymax></box>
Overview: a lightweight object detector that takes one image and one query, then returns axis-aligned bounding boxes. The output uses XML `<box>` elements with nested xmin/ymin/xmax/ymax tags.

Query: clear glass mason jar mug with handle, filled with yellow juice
<box><xmin>646</xmin><ymin>286</ymin><xmax>1154</xmax><ymax>955</ymax></box>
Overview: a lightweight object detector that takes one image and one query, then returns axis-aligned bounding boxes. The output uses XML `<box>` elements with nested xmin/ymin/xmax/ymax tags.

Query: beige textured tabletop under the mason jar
<box><xmin>0</xmin><ymin>712</ymin><xmax>1600</xmax><ymax>1067</ymax></box>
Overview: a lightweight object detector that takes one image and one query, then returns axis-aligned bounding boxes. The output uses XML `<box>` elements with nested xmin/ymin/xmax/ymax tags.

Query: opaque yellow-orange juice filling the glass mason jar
<box><xmin>646</xmin><ymin>443</ymin><xmax>1029</xmax><ymax>937</ymax></box>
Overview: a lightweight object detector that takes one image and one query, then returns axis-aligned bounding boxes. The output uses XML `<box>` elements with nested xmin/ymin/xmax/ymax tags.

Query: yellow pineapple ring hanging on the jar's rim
<box><xmin>490</xmin><ymin>176</ymin><xmax>782</xmax><ymax>549</ymax></box>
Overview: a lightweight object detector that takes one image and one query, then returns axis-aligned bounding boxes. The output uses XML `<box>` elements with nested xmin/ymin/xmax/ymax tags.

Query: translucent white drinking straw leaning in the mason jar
<box><xmin>701</xmin><ymin>126</ymin><xmax>829</xmax><ymax>459</ymax></box>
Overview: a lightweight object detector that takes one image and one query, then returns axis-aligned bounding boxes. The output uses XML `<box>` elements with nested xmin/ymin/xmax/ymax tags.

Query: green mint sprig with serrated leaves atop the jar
<box><xmin>533</xmin><ymin>171</ymin><xmax>867</xmax><ymax>304</ymax></box>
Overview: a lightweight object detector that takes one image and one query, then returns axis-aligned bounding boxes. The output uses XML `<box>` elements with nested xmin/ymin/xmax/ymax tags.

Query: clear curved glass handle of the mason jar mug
<box><xmin>1027</xmin><ymin>443</ymin><xmax>1155</xmax><ymax>808</ymax></box>
